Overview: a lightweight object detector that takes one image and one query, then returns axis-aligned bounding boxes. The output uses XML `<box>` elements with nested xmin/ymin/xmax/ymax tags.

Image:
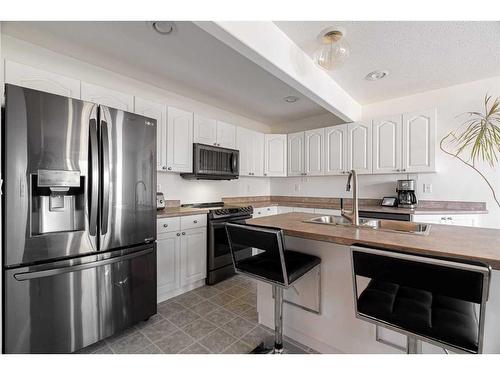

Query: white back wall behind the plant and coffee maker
<box><xmin>271</xmin><ymin>77</ymin><xmax>500</xmax><ymax>228</ymax></box>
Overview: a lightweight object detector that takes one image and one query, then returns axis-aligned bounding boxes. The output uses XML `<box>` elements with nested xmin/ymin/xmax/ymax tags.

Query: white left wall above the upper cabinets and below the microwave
<box><xmin>1</xmin><ymin>35</ymin><xmax>270</xmax><ymax>203</ymax></box>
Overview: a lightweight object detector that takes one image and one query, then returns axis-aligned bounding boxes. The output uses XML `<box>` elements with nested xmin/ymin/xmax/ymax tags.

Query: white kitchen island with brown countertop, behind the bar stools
<box><xmin>248</xmin><ymin>212</ymin><xmax>500</xmax><ymax>353</ymax></box>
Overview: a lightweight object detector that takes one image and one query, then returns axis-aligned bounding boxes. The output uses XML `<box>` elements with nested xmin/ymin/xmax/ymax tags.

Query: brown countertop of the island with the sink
<box><xmin>248</xmin><ymin>212</ymin><xmax>500</xmax><ymax>270</ymax></box>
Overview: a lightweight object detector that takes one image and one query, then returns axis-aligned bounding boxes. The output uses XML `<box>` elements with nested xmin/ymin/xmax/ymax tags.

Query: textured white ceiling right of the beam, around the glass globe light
<box><xmin>275</xmin><ymin>21</ymin><xmax>500</xmax><ymax>104</ymax></box>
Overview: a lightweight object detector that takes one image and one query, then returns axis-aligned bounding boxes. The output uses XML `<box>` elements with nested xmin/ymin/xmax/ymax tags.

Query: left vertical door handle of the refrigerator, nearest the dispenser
<box><xmin>88</xmin><ymin>118</ymin><xmax>99</xmax><ymax>236</ymax></box>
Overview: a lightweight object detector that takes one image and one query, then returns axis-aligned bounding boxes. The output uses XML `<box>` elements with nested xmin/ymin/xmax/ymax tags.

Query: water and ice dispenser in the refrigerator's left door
<box><xmin>31</xmin><ymin>169</ymin><xmax>85</xmax><ymax>236</ymax></box>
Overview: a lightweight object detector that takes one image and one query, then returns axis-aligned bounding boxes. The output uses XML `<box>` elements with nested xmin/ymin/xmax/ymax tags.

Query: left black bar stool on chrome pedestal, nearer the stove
<box><xmin>226</xmin><ymin>223</ymin><xmax>321</xmax><ymax>354</ymax></box>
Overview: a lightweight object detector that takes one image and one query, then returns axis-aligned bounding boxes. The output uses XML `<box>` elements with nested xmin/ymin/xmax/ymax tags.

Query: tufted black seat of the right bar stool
<box><xmin>358</xmin><ymin>279</ymin><xmax>479</xmax><ymax>352</ymax></box>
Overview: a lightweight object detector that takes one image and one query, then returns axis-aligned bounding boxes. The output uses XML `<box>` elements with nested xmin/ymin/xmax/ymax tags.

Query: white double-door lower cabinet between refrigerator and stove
<box><xmin>156</xmin><ymin>215</ymin><xmax>207</xmax><ymax>302</ymax></box>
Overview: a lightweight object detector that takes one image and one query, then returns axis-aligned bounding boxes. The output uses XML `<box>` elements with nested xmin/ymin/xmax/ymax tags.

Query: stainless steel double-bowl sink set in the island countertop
<box><xmin>304</xmin><ymin>216</ymin><xmax>431</xmax><ymax>236</ymax></box>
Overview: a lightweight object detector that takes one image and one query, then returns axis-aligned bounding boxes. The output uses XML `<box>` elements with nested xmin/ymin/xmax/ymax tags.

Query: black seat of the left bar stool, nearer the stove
<box><xmin>238</xmin><ymin>250</ymin><xmax>321</xmax><ymax>284</ymax></box>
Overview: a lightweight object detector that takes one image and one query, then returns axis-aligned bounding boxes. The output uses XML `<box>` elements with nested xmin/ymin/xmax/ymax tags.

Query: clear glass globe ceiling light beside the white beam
<box><xmin>315</xmin><ymin>27</ymin><xmax>351</xmax><ymax>70</ymax></box>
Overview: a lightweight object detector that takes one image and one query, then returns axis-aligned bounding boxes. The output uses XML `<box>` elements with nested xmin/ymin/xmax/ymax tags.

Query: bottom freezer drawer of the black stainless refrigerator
<box><xmin>4</xmin><ymin>245</ymin><xmax>156</xmax><ymax>353</ymax></box>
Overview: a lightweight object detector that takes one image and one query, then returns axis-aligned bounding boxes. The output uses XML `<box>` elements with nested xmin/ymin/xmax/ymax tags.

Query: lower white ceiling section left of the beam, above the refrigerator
<box><xmin>2</xmin><ymin>21</ymin><xmax>341</xmax><ymax>125</ymax></box>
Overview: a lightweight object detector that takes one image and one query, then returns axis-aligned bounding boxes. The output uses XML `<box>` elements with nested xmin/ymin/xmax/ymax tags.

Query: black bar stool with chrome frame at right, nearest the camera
<box><xmin>351</xmin><ymin>246</ymin><xmax>491</xmax><ymax>354</ymax></box>
